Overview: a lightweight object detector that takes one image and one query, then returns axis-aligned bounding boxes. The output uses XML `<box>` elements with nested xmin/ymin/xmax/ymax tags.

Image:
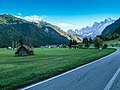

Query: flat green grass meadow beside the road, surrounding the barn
<box><xmin>0</xmin><ymin>48</ymin><xmax>115</xmax><ymax>90</ymax></box>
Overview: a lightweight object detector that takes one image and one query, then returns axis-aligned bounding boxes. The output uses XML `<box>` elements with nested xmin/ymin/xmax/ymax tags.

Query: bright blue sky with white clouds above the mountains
<box><xmin>0</xmin><ymin>0</ymin><xmax>120</xmax><ymax>31</ymax></box>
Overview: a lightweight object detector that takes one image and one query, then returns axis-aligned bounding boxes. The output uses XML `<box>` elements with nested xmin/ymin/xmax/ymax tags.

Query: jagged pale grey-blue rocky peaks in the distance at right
<box><xmin>67</xmin><ymin>18</ymin><xmax>115</xmax><ymax>38</ymax></box>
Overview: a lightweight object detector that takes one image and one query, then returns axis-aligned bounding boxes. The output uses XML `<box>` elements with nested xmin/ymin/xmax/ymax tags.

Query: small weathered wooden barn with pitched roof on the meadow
<box><xmin>15</xmin><ymin>45</ymin><xmax>34</xmax><ymax>56</ymax></box>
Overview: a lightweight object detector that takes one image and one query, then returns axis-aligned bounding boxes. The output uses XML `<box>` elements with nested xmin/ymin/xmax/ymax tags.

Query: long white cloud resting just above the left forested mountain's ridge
<box><xmin>16</xmin><ymin>14</ymin><xmax>47</xmax><ymax>23</ymax></box>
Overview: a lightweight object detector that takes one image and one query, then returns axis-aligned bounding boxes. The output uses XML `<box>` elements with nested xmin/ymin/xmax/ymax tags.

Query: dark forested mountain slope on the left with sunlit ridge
<box><xmin>0</xmin><ymin>14</ymin><xmax>80</xmax><ymax>47</ymax></box>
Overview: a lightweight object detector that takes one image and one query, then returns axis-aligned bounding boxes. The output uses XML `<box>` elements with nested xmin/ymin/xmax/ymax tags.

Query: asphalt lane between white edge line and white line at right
<box><xmin>23</xmin><ymin>48</ymin><xmax>120</xmax><ymax>90</ymax></box>
